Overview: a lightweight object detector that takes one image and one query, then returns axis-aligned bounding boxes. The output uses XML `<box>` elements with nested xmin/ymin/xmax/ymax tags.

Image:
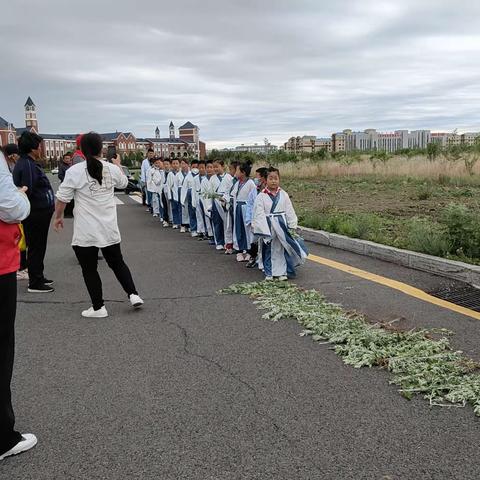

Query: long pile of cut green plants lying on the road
<box><xmin>220</xmin><ymin>281</ymin><xmax>480</xmax><ymax>416</ymax></box>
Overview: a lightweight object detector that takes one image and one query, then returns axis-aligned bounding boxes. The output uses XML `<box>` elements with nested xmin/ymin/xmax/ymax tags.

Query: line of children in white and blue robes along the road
<box><xmin>141</xmin><ymin>151</ymin><xmax>308</xmax><ymax>280</ymax></box>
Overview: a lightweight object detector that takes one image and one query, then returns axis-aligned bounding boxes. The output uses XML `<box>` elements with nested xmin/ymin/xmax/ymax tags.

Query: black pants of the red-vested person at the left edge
<box><xmin>0</xmin><ymin>272</ymin><xmax>22</xmax><ymax>455</ymax></box>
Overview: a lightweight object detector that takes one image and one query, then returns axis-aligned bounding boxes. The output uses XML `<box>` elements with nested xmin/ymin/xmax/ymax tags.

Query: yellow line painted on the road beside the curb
<box><xmin>308</xmin><ymin>255</ymin><xmax>480</xmax><ymax>320</ymax></box>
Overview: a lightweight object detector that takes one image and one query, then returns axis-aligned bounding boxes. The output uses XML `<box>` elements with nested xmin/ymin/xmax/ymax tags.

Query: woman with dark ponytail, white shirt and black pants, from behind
<box><xmin>54</xmin><ymin>132</ymin><xmax>143</xmax><ymax>318</ymax></box>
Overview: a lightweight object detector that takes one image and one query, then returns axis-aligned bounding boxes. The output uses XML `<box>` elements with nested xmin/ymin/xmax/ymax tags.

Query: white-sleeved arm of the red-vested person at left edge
<box><xmin>0</xmin><ymin>153</ymin><xmax>30</xmax><ymax>223</ymax></box>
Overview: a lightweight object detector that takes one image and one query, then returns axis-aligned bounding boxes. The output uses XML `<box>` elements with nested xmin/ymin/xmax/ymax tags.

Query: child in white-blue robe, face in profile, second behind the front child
<box><xmin>231</xmin><ymin>163</ymin><xmax>257</xmax><ymax>262</ymax></box>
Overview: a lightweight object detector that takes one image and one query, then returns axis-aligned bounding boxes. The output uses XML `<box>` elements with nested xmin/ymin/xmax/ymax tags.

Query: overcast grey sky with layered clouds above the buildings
<box><xmin>0</xmin><ymin>0</ymin><xmax>480</xmax><ymax>148</ymax></box>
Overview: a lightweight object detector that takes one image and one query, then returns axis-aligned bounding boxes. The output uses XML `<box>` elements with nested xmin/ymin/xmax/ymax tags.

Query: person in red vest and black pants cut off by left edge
<box><xmin>0</xmin><ymin>152</ymin><xmax>37</xmax><ymax>460</ymax></box>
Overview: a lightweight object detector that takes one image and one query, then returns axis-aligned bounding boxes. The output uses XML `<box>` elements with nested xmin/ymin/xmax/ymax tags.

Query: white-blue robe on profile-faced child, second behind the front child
<box><xmin>232</xmin><ymin>178</ymin><xmax>257</xmax><ymax>253</ymax></box>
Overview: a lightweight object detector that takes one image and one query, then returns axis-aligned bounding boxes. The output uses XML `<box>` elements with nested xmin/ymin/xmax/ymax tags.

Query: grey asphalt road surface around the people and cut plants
<box><xmin>0</xmin><ymin>196</ymin><xmax>480</xmax><ymax>480</ymax></box>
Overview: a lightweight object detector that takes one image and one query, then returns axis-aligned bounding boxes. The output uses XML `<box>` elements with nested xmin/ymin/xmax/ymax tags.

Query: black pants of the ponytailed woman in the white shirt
<box><xmin>73</xmin><ymin>243</ymin><xmax>137</xmax><ymax>310</ymax></box>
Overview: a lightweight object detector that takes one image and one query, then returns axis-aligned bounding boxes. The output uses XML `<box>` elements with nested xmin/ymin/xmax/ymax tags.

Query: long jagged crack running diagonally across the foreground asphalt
<box><xmin>168</xmin><ymin>314</ymin><xmax>322</xmax><ymax>473</ymax></box>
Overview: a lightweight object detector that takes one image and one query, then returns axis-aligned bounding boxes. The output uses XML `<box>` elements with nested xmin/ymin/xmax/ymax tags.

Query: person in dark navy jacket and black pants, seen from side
<box><xmin>13</xmin><ymin>132</ymin><xmax>55</xmax><ymax>293</ymax></box>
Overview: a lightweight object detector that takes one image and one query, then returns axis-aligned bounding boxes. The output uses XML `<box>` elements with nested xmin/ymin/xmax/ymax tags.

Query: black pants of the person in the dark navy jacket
<box><xmin>22</xmin><ymin>208</ymin><xmax>53</xmax><ymax>287</ymax></box>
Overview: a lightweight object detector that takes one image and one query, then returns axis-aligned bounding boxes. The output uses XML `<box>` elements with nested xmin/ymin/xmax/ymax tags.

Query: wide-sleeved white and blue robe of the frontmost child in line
<box><xmin>252</xmin><ymin>189</ymin><xmax>308</xmax><ymax>277</ymax></box>
